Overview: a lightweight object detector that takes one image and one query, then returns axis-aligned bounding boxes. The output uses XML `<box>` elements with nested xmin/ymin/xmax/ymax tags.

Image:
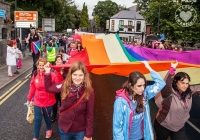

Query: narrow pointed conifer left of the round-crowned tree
<box><xmin>80</xmin><ymin>2</ymin><xmax>89</xmax><ymax>28</ymax></box>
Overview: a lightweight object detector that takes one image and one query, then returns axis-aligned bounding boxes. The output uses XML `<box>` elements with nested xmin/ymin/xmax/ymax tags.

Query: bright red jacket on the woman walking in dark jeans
<box><xmin>27</xmin><ymin>71</ymin><xmax>62</xmax><ymax>107</ymax></box>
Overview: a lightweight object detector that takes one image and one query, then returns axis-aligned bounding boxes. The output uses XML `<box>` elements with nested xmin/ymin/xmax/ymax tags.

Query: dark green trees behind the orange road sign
<box><xmin>5</xmin><ymin>0</ymin><xmax>80</xmax><ymax>31</ymax></box>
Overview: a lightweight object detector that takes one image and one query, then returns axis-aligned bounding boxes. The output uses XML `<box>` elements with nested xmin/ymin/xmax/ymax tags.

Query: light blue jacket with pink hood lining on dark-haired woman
<box><xmin>113</xmin><ymin>71</ymin><xmax>165</xmax><ymax>140</ymax></box>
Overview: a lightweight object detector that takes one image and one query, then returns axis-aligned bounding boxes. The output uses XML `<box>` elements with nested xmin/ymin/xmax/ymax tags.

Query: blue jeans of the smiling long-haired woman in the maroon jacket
<box><xmin>58</xmin><ymin>126</ymin><xmax>85</xmax><ymax>140</ymax></box>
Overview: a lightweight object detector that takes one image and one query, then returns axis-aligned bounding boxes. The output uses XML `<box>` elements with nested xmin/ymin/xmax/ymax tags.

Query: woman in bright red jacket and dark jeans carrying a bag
<box><xmin>27</xmin><ymin>58</ymin><xmax>61</xmax><ymax>140</ymax></box>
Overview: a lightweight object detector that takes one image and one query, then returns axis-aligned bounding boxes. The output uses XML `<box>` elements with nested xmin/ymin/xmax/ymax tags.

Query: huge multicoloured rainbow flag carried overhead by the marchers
<box><xmin>51</xmin><ymin>34</ymin><xmax>200</xmax><ymax>84</ymax></box>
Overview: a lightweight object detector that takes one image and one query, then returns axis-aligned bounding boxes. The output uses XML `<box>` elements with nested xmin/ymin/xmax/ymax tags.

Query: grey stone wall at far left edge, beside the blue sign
<box><xmin>0</xmin><ymin>1</ymin><xmax>11</xmax><ymax>66</ymax></box>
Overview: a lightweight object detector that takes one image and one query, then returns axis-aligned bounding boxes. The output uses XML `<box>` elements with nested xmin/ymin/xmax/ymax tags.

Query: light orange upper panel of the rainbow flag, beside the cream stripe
<box><xmin>81</xmin><ymin>34</ymin><xmax>110</xmax><ymax>65</ymax></box>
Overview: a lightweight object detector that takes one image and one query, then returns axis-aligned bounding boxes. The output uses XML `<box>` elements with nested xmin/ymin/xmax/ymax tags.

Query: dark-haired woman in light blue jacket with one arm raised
<box><xmin>113</xmin><ymin>61</ymin><xmax>165</xmax><ymax>140</ymax></box>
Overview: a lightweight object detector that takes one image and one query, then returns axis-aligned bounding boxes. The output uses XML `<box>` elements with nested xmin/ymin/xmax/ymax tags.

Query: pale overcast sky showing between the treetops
<box><xmin>75</xmin><ymin>0</ymin><xmax>133</xmax><ymax>19</ymax></box>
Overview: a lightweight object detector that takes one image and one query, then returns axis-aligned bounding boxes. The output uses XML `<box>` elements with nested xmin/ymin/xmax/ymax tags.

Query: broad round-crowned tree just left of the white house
<box><xmin>92</xmin><ymin>0</ymin><xmax>119</xmax><ymax>29</ymax></box>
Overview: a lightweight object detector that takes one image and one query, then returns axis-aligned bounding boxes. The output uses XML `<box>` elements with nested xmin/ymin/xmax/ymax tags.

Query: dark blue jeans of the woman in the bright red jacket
<box><xmin>34</xmin><ymin>106</ymin><xmax>53</xmax><ymax>138</ymax></box>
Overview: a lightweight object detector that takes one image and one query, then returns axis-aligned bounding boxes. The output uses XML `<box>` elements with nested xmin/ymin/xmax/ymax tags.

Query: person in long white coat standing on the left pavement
<box><xmin>6</xmin><ymin>40</ymin><xmax>17</xmax><ymax>77</ymax></box>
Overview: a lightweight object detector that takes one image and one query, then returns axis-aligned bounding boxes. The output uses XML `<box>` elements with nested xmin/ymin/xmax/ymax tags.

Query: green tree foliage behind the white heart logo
<box><xmin>134</xmin><ymin>0</ymin><xmax>200</xmax><ymax>43</ymax></box>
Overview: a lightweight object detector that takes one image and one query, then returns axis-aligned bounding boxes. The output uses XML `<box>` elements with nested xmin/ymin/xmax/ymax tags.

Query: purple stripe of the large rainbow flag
<box><xmin>131</xmin><ymin>47</ymin><xmax>200</xmax><ymax>65</ymax></box>
